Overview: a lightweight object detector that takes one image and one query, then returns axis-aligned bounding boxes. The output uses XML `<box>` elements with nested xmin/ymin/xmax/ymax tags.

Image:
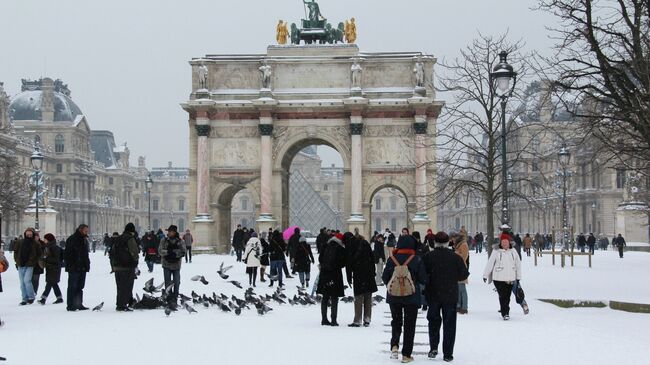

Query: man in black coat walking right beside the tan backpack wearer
<box><xmin>423</xmin><ymin>232</ymin><xmax>469</xmax><ymax>361</ymax></box>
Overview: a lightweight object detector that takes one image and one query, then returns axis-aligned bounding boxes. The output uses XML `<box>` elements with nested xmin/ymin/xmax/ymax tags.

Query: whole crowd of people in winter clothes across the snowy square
<box><xmin>0</xmin><ymin>223</ymin><xmax>625</xmax><ymax>363</ymax></box>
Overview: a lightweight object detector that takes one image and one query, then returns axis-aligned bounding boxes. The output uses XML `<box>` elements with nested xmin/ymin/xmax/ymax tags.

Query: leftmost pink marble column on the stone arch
<box><xmin>196</xmin><ymin>113</ymin><xmax>210</xmax><ymax>218</ymax></box>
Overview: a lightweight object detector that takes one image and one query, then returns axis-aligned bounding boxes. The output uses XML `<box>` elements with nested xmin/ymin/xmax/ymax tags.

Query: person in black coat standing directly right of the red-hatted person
<box><xmin>345</xmin><ymin>235</ymin><xmax>374</xmax><ymax>327</ymax></box>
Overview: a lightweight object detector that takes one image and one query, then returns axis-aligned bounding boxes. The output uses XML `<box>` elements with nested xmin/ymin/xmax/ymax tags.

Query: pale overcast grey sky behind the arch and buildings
<box><xmin>0</xmin><ymin>0</ymin><xmax>555</xmax><ymax>166</ymax></box>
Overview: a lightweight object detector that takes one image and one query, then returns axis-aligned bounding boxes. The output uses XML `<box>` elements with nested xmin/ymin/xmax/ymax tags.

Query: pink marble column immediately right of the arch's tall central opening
<box><xmin>350</xmin><ymin>112</ymin><xmax>363</xmax><ymax>219</ymax></box>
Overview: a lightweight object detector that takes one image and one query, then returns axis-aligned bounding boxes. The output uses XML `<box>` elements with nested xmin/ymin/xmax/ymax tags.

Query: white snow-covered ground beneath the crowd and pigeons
<box><xmin>0</xmin><ymin>247</ymin><xmax>650</xmax><ymax>365</ymax></box>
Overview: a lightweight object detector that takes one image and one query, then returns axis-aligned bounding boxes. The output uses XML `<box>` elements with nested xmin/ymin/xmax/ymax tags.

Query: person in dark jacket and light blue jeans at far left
<box><xmin>13</xmin><ymin>227</ymin><xmax>42</xmax><ymax>305</ymax></box>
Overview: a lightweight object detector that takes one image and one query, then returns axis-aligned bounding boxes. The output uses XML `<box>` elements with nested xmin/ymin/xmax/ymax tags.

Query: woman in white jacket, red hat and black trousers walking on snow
<box><xmin>483</xmin><ymin>233</ymin><xmax>521</xmax><ymax>321</ymax></box>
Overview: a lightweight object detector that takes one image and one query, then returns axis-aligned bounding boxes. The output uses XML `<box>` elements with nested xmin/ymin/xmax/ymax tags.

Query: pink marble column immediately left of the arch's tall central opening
<box><xmin>259</xmin><ymin>112</ymin><xmax>273</xmax><ymax>217</ymax></box>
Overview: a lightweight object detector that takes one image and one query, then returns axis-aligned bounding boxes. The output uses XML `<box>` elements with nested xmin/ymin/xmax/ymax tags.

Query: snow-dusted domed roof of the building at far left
<box><xmin>9</xmin><ymin>83</ymin><xmax>83</xmax><ymax>122</ymax></box>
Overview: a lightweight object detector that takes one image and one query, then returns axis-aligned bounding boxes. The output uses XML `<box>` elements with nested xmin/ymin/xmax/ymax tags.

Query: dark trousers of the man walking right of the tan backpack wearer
<box><xmin>427</xmin><ymin>302</ymin><xmax>456</xmax><ymax>356</ymax></box>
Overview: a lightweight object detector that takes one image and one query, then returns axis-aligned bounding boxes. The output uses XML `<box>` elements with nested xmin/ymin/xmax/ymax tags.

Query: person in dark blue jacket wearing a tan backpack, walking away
<box><xmin>382</xmin><ymin>235</ymin><xmax>428</xmax><ymax>363</ymax></box>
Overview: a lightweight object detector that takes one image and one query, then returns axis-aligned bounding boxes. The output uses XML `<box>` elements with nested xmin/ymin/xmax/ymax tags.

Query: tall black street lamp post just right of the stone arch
<box><xmin>490</xmin><ymin>51</ymin><xmax>517</xmax><ymax>231</ymax></box>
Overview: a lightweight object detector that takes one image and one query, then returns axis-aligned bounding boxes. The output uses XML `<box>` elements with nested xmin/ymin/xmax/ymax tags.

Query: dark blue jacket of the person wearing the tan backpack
<box><xmin>381</xmin><ymin>249</ymin><xmax>429</xmax><ymax>306</ymax></box>
